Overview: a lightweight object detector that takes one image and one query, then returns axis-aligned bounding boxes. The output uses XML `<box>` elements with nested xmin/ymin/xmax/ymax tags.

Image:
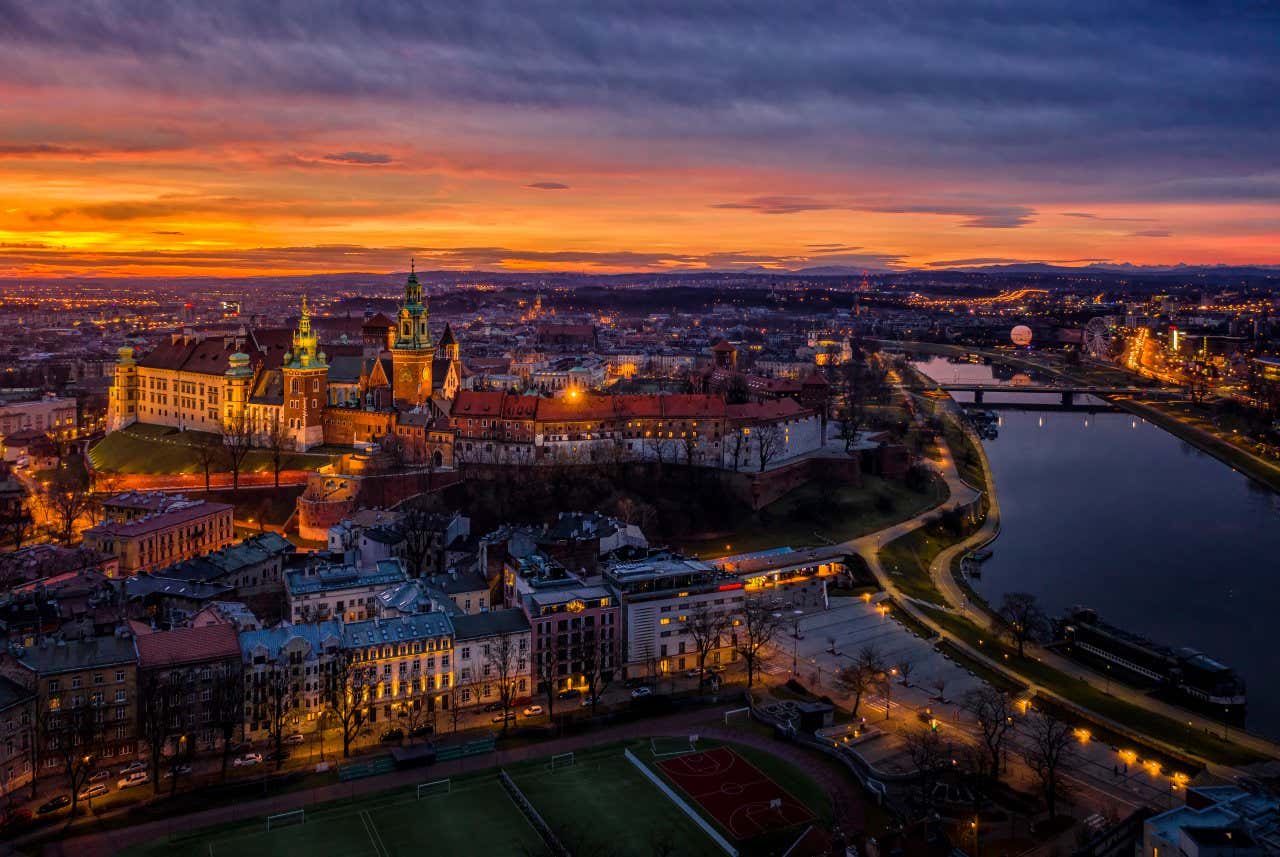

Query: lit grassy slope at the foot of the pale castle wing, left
<box><xmin>88</xmin><ymin>425</ymin><xmax>333</xmax><ymax>475</ymax></box>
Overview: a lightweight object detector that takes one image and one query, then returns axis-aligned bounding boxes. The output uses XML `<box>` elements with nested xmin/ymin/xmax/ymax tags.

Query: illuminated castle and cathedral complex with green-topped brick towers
<box><xmin>108</xmin><ymin>271</ymin><xmax>462</xmax><ymax>463</ymax></box>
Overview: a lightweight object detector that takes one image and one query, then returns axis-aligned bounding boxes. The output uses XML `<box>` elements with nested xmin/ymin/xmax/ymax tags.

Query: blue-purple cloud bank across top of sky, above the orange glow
<box><xmin>0</xmin><ymin>0</ymin><xmax>1280</xmax><ymax>193</ymax></box>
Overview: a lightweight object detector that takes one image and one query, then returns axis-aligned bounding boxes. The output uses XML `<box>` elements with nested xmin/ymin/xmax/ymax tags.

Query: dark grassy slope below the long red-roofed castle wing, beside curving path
<box><xmin>681</xmin><ymin>475</ymin><xmax>946</xmax><ymax>558</ymax></box>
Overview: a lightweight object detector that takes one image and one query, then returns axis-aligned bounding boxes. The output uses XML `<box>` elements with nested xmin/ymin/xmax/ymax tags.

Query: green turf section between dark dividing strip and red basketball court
<box><xmin>509</xmin><ymin>742</ymin><xmax>723</xmax><ymax>857</ymax></box>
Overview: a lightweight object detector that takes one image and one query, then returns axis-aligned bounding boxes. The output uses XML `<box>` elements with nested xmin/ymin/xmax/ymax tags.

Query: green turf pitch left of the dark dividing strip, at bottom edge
<box><xmin>124</xmin><ymin>773</ymin><xmax>541</xmax><ymax>857</ymax></box>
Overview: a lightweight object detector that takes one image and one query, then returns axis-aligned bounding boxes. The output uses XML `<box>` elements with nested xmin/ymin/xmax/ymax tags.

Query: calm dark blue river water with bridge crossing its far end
<box><xmin>915</xmin><ymin>357</ymin><xmax>1280</xmax><ymax>737</ymax></box>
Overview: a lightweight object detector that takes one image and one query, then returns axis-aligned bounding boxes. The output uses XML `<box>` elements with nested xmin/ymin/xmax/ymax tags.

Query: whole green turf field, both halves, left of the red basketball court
<box><xmin>124</xmin><ymin>741</ymin><xmax>723</xmax><ymax>857</ymax></box>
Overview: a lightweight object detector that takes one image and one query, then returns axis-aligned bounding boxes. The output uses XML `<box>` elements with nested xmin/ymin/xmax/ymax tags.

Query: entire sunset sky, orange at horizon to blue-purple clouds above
<box><xmin>0</xmin><ymin>0</ymin><xmax>1280</xmax><ymax>278</ymax></box>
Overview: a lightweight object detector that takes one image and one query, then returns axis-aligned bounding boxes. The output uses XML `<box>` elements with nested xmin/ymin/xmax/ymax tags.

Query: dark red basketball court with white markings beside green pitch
<box><xmin>658</xmin><ymin>747</ymin><xmax>814</xmax><ymax>839</ymax></box>
